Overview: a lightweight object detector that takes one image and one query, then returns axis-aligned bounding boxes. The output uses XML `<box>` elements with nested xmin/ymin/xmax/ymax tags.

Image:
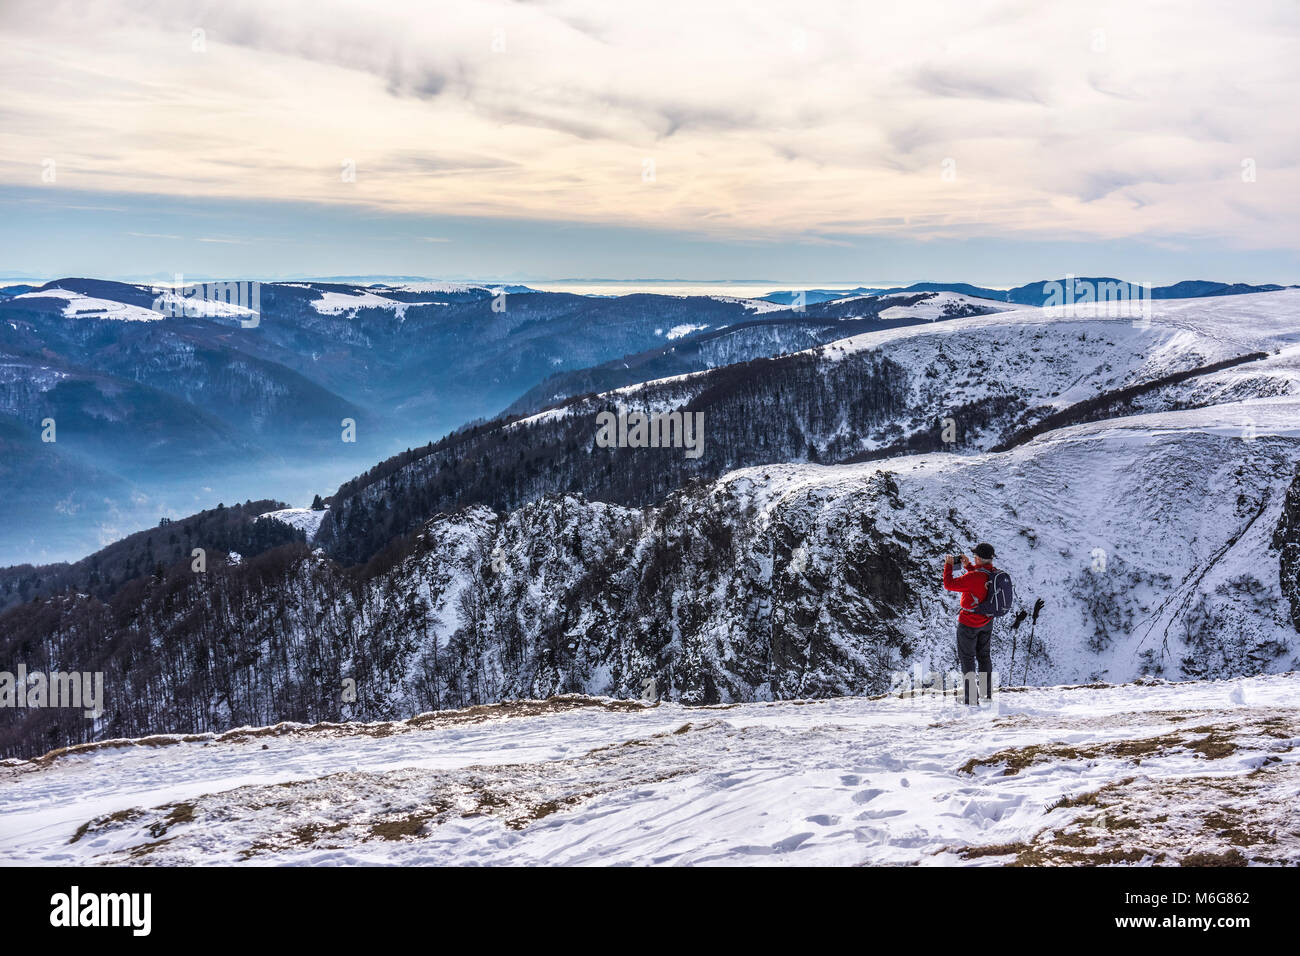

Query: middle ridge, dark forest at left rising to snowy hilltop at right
<box><xmin>319</xmin><ymin>291</ymin><xmax>1300</xmax><ymax>563</ymax></box>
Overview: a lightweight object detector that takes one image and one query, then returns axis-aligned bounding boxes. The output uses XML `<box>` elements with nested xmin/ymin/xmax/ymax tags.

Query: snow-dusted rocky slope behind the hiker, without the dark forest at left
<box><xmin>395</xmin><ymin>398</ymin><xmax>1300</xmax><ymax>700</ymax></box>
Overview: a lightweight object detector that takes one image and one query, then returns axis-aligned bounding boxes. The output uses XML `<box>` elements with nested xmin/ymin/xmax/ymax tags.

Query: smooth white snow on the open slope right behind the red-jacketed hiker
<box><xmin>719</xmin><ymin>397</ymin><xmax>1300</xmax><ymax>683</ymax></box>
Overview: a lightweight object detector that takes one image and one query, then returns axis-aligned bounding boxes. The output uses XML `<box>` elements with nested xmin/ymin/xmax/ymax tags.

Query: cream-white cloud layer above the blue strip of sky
<box><xmin>0</xmin><ymin>0</ymin><xmax>1300</xmax><ymax>248</ymax></box>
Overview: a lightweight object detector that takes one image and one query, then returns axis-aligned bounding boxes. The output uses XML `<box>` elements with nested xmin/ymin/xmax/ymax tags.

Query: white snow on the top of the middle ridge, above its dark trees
<box><xmin>519</xmin><ymin>289</ymin><xmax>1300</xmax><ymax>450</ymax></box>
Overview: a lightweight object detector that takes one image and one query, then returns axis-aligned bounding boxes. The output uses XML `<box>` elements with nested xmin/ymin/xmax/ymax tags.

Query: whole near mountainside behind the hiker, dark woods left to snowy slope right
<box><xmin>0</xmin><ymin>398</ymin><xmax>1300</xmax><ymax>756</ymax></box>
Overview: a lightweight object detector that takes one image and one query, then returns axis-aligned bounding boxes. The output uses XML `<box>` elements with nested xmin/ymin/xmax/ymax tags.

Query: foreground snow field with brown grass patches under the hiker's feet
<box><xmin>0</xmin><ymin>674</ymin><xmax>1300</xmax><ymax>865</ymax></box>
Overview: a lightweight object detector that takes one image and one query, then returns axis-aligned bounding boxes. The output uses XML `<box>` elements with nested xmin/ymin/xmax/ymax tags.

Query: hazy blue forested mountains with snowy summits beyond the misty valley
<box><xmin>0</xmin><ymin>278</ymin><xmax>780</xmax><ymax>563</ymax></box>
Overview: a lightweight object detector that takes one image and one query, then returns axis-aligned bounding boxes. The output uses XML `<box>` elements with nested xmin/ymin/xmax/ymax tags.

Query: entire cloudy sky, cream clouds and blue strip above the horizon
<box><xmin>0</xmin><ymin>0</ymin><xmax>1300</xmax><ymax>285</ymax></box>
